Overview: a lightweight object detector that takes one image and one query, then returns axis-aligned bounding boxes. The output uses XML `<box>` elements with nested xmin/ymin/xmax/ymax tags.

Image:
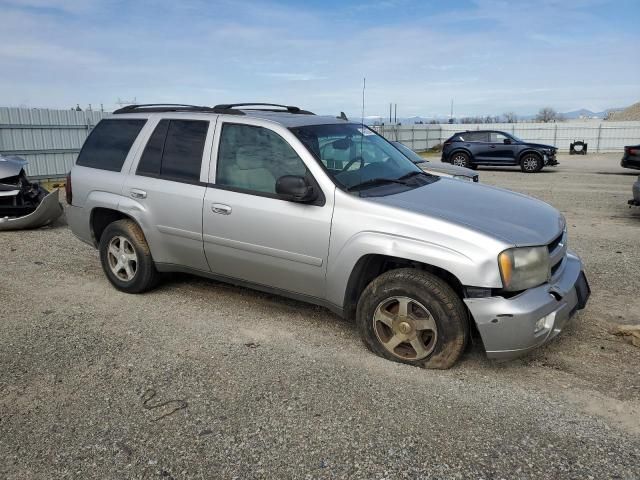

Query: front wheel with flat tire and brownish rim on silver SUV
<box><xmin>356</xmin><ymin>268</ymin><xmax>469</xmax><ymax>369</ymax></box>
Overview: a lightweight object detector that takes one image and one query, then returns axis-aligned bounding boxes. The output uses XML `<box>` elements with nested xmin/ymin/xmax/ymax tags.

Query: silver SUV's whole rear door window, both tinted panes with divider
<box><xmin>136</xmin><ymin>120</ymin><xmax>209</xmax><ymax>182</ymax></box>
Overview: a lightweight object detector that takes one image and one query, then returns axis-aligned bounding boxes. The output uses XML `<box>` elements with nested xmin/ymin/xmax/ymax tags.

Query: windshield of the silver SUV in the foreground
<box><xmin>291</xmin><ymin>123</ymin><xmax>433</xmax><ymax>194</ymax></box>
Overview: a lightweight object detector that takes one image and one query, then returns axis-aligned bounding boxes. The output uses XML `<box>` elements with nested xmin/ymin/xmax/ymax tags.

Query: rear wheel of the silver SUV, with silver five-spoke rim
<box><xmin>98</xmin><ymin>220</ymin><xmax>158</xmax><ymax>293</ymax></box>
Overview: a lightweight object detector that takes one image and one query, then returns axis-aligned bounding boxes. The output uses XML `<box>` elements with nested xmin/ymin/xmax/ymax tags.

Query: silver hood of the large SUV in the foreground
<box><xmin>367</xmin><ymin>178</ymin><xmax>565</xmax><ymax>246</ymax></box>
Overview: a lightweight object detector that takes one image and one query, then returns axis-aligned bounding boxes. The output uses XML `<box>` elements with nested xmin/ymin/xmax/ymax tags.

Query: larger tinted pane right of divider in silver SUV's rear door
<box><xmin>160</xmin><ymin>120</ymin><xmax>209</xmax><ymax>182</ymax></box>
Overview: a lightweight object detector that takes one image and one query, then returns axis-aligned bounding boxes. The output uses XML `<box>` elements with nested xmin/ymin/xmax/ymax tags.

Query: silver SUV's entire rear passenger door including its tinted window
<box><xmin>122</xmin><ymin>116</ymin><xmax>215</xmax><ymax>271</ymax></box>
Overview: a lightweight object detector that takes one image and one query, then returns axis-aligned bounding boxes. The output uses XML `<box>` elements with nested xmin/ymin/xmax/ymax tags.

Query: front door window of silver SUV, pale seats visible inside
<box><xmin>216</xmin><ymin>124</ymin><xmax>307</xmax><ymax>195</ymax></box>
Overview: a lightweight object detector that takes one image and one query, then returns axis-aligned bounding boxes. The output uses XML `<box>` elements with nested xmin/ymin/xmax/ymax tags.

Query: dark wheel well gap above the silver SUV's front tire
<box><xmin>344</xmin><ymin>255</ymin><xmax>464</xmax><ymax>319</ymax></box>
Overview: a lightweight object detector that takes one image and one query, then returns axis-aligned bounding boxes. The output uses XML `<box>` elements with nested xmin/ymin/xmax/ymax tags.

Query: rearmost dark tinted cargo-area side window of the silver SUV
<box><xmin>76</xmin><ymin>119</ymin><xmax>146</xmax><ymax>172</ymax></box>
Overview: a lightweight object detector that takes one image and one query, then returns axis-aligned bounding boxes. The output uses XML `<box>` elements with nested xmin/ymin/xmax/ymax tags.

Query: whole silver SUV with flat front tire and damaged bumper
<box><xmin>67</xmin><ymin>104</ymin><xmax>589</xmax><ymax>368</ymax></box>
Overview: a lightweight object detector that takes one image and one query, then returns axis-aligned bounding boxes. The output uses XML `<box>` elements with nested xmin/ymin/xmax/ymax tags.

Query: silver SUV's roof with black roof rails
<box><xmin>113</xmin><ymin>103</ymin><xmax>351</xmax><ymax>128</ymax></box>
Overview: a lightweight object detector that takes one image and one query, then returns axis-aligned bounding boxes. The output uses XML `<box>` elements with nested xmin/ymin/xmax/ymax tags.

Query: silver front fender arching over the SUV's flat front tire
<box><xmin>327</xmin><ymin>231</ymin><xmax>502</xmax><ymax>305</ymax></box>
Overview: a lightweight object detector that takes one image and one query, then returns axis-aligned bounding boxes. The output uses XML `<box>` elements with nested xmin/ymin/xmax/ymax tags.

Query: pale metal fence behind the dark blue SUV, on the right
<box><xmin>374</xmin><ymin>122</ymin><xmax>640</xmax><ymax>153</ymax></box>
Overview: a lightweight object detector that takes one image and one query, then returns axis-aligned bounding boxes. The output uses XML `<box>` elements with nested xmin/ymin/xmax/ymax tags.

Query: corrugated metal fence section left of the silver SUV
<box><xmin>0</xmin><ymin>107</ymin><xmax>109</xmax><ymax>178</ymax></box>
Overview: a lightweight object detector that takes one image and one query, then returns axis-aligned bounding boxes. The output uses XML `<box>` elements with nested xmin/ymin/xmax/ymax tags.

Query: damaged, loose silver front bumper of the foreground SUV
<box><xmin>464</xmin><ymin>252</ymin><xmax>590</xmax><ymax>360</ymax></box>
